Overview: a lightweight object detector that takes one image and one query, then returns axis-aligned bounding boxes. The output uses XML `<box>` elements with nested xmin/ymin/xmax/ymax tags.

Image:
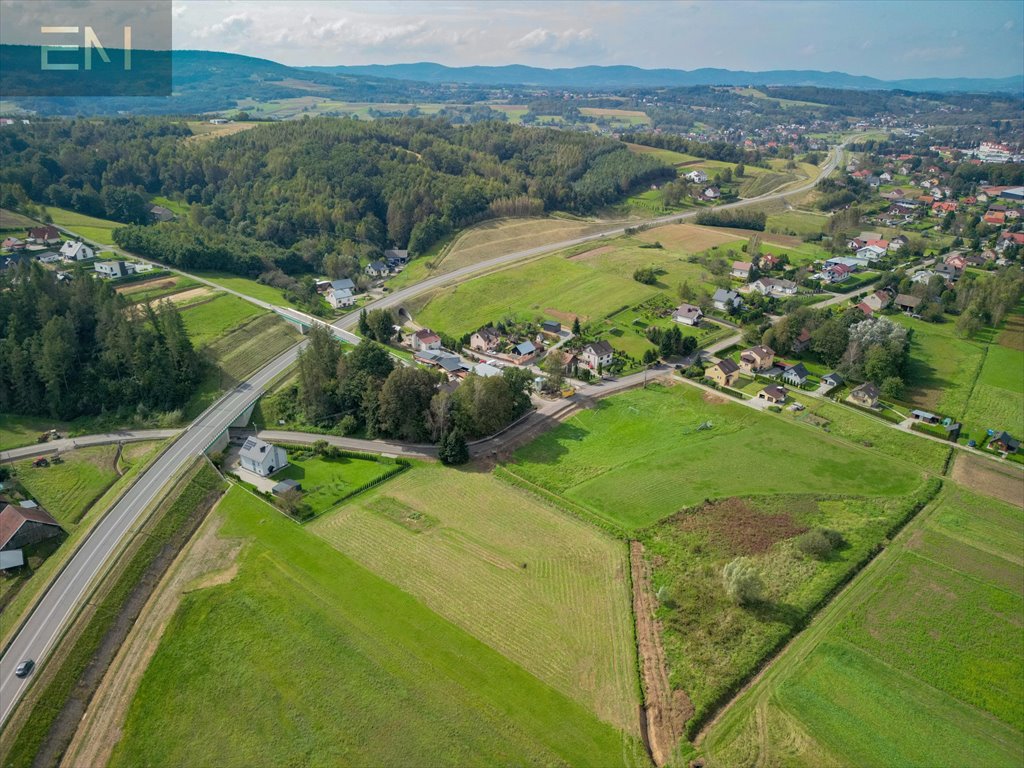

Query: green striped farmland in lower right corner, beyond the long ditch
<box><xmin>705</xmin><ymin>485</ymin><xmax>1024</xmax><ymax>768</ymax></box>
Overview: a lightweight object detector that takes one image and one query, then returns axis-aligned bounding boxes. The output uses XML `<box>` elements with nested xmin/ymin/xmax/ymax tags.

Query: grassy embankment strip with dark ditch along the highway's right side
<box><xmin>0</xmin><ymin>459</ymin><xmax>223</xmax><ymax>766</ymax></box>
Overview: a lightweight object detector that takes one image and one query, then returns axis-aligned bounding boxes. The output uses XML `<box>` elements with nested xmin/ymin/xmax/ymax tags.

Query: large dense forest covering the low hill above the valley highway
<box><xmin>0</xmin><ymin>118</ymin><xmax>675</xmax><ymax>273</ymax></box>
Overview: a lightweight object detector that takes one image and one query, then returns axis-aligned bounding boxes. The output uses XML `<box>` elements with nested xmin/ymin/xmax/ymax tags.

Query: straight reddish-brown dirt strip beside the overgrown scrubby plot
<box><xmin>630</xmin><ymin>542</ymin><xmax>693</xmax><ymax>766</ymax></box>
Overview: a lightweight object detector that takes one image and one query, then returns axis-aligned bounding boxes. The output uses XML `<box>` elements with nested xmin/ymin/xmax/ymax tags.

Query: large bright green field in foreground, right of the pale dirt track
<box><xmin>111</xmin><ymin>486</ymin><xmax>644</xmax><ymax>768</ymax></box>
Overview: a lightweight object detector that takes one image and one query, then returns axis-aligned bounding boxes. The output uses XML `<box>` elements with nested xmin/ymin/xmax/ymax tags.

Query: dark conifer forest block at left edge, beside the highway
<box><xmin>0</xmin><ymin>262</ymin><xmax>203</xmax><ymax>419</ymax></box>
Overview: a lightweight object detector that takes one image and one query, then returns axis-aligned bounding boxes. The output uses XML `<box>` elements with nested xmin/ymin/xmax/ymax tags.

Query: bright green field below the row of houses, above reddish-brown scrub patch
<box><xmin>508</xmin><ymin>384</ymin><xmax>920</xmax><ymax>531</ymax></box>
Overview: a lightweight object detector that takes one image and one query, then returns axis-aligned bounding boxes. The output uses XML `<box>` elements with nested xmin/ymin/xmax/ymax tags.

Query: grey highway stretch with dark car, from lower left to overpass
<box><xmin>0</xmin><ymin>346</ymin><xmax>298</xmax><ymax>725</ymax></box>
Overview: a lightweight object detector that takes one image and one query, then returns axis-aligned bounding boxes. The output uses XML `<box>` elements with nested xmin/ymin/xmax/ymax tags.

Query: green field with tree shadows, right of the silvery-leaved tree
<box><xmin>892</xmin><ymin>314</ymin><xmax>987</xmax><ymax>419</ymax></box>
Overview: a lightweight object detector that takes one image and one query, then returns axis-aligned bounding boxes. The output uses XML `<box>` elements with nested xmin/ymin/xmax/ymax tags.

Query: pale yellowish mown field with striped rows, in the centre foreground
<box><xmin>309</xmin><ymin>465</ymin><xmax>639</xmax><ymax>733</ymax></box>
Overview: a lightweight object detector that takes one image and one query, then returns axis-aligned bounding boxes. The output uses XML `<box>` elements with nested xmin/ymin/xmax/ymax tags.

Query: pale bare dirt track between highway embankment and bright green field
<box><xmin>60</xmin><ymin>508</ymin><xmax>242</xmax><ymax>768</ymax></box>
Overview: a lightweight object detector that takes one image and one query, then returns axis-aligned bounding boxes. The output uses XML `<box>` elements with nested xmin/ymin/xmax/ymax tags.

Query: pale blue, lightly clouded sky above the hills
<box><xmin>0</xmin><ymin>0</ymin><xmax>1024</xmax><ymax>80</ymax></box>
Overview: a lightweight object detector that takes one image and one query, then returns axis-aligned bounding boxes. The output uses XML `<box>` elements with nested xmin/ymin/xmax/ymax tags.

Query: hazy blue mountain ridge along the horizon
<box><xmin>302</xmin><ymin>61</ymin><xmax>1024</xmax><ymax>93</ymax></box>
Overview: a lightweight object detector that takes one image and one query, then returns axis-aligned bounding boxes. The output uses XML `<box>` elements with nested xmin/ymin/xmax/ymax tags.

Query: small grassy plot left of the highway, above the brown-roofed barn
<box><xmin>14</xmin><ymin>445</ymin><xmax>119</xmax><ymax>525</ymax></box>
